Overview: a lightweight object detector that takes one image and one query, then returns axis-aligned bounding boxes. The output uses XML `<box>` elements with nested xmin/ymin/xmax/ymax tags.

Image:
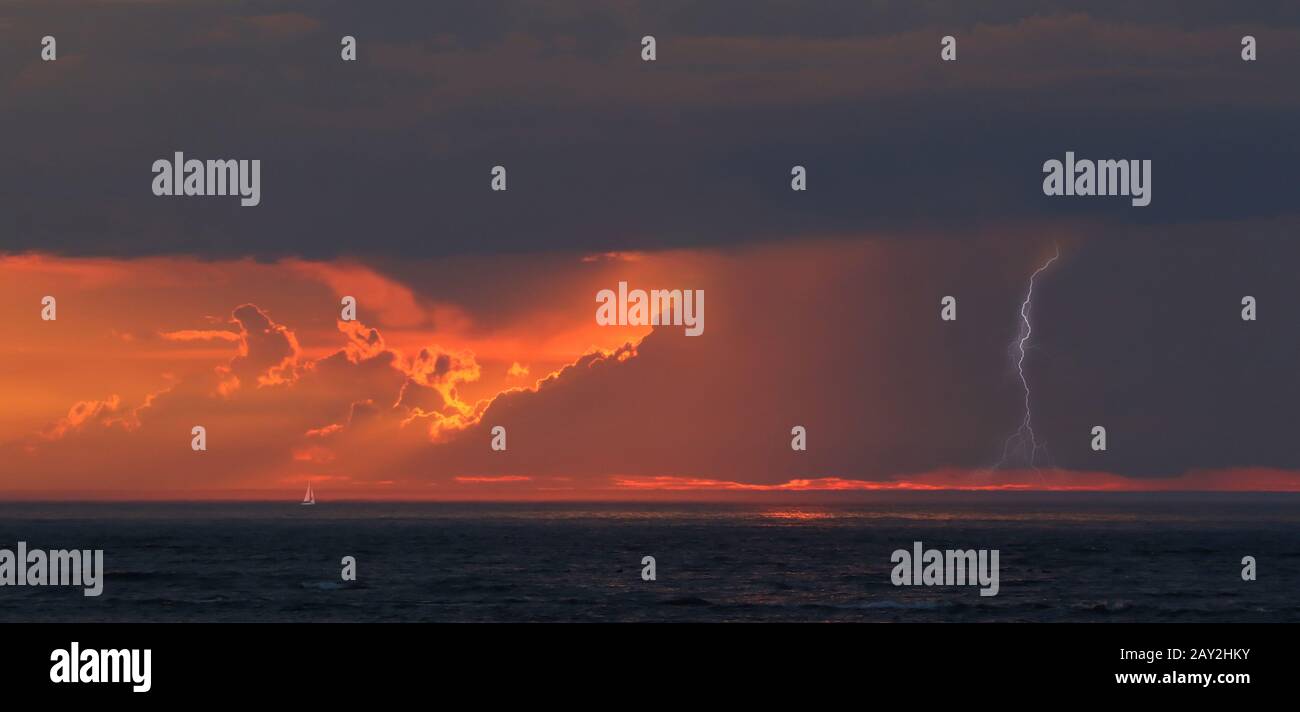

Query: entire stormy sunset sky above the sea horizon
<box><xmin>0</xmin><ymin>0</ymin><xmax>1300</xmax><ymax>499</ymax></box>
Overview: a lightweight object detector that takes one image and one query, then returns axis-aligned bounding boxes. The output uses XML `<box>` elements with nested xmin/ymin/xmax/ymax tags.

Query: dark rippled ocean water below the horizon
<box><xmin>0</xmin><ymin>492</ymin><xmax>1300</xmax><ymax>622</ymax></box>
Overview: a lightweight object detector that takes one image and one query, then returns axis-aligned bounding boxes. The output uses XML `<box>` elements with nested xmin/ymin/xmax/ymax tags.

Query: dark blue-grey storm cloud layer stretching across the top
<box><xmin>0</xmin><ymin>1</ymin><xmax>1300</xmax><ymax>257</ymax></box>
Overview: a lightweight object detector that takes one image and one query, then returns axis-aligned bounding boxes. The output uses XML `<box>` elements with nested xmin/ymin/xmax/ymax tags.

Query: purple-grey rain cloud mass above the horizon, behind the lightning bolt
<box><xmin>379</xmin><ymin>230</ymin><xmax>1300</xmax><ymax>485</ymax></box>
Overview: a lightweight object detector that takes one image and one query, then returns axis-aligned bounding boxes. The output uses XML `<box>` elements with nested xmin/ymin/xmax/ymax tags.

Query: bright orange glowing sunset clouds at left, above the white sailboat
<box><xmin>0</xmin><ymin>249</ymin><xmax>681</xmax><ymax>494</ymax></box>
